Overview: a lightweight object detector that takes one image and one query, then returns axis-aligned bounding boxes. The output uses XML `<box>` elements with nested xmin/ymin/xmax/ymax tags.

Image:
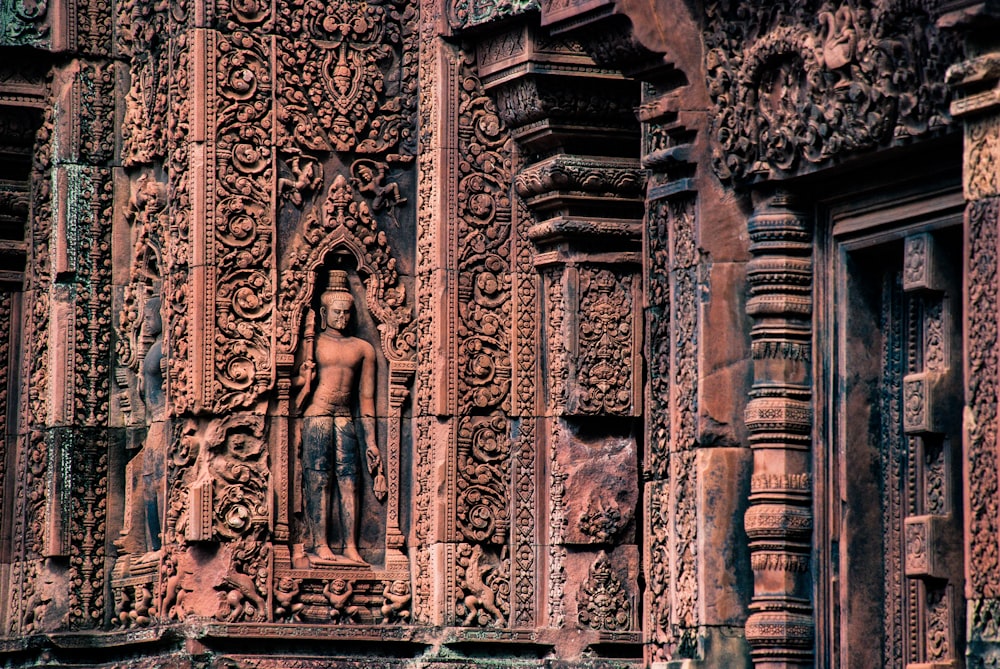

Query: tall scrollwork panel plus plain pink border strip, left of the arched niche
<box><xmin>191</xmin><ymin>31</ymin><xmax>275</xmax><ymax>412</ymax></box>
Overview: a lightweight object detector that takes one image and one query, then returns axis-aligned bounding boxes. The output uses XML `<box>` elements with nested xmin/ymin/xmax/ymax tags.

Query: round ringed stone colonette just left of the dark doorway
<box><xmin>744</xmin><ymin>194</ymin><xmax>814</xmax><ymax>667</ymax></box>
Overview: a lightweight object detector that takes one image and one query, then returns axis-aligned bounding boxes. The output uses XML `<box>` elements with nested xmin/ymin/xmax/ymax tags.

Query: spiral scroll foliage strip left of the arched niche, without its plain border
<box><xmin>209</xmin><ymin>32</ymin><xmax>275</xmax><ymax>412</ymax></box>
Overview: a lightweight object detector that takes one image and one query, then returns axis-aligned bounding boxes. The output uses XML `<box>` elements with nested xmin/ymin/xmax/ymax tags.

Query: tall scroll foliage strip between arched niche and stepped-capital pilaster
<box><xmin>450</xmin><ymin>52</ymin><xmax>513</xmax><ymax>592</ymax></box>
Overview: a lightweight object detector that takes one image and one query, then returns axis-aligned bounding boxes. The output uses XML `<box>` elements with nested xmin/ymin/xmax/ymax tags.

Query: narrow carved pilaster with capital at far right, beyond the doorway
<box><xmin>940</xmin><ymin>32</ymin><xmax>1000</xmax><ymax>667</ymax></box>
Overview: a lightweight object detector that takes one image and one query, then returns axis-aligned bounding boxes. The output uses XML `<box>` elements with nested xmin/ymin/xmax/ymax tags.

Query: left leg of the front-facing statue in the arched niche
<box><xmin>302</xmin><ymin>416</ymin><xmax>334</xmax><ymax>560</ymax></box>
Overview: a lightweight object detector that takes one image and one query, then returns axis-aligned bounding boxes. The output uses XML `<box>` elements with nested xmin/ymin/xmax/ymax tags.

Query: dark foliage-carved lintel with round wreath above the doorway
<box><xmin>706</xmin><ymin>0</ymin><xmax>959</xmax><ymax>181</ymax></box>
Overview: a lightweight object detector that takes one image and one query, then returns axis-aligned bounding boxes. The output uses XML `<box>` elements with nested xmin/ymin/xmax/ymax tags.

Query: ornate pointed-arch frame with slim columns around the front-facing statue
<box><xmin>270</xmin><ymin>175</ymin><xmax>416</xmax><ymax>579</ymax></box>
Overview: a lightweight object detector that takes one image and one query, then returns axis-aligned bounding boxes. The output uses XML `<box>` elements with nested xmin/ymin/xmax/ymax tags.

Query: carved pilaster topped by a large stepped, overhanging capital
<box><xmin>466</xmin><ymin>16</ymin><xmax>645</xmax><ymax>642</ymax></box>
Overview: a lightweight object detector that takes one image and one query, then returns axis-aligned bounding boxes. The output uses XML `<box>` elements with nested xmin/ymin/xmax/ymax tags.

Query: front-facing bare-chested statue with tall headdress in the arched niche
<box><xmin>296</xmin><ymin>270</ymin><xmax>387</xmax><ymax>566</ymax></box>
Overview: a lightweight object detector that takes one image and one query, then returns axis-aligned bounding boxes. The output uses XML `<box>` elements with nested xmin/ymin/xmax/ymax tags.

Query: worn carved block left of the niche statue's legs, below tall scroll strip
<box><xmin>155</xmin><ymin>412</ymin><xmax>271</xmax><ymax>622</ymax></box>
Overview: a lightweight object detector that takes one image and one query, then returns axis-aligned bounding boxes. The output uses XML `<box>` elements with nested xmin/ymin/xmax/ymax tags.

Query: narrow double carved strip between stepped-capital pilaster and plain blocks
<box><xmin>645</xmin><ymin>197</ymin><xmax>699</xmax><ymax>660</ymax></box>
